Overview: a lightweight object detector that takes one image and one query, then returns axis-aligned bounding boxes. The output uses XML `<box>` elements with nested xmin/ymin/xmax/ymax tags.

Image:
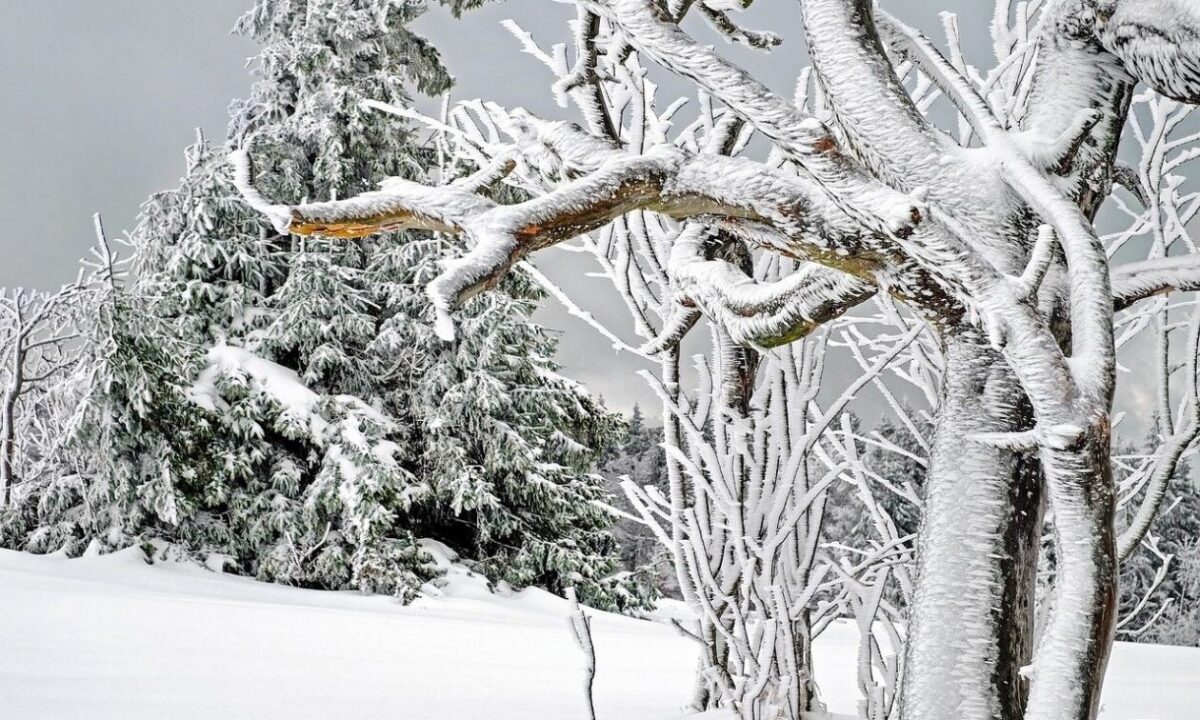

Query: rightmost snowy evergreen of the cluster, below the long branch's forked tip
<box><xmin>386</xmin><ymin>278</ymin><xmax>641</xmax><ymax>608</ymax></box>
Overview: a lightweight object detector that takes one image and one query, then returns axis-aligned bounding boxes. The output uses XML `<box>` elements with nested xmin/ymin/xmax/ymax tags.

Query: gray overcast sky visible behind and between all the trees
<box><xmin>0</xmin><ymin>0</ymin><xmax>1152</xmax><ymax>410</ymax></box>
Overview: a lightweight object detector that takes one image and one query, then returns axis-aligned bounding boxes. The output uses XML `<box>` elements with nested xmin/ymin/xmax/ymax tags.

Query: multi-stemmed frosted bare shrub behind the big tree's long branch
<box><xmin>403</xmin><ymin>30</ymin><xmax>864</xmax><ymax>719</ymax></box>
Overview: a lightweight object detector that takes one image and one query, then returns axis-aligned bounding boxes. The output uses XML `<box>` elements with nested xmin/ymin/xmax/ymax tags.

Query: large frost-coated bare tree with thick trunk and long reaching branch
<box><xmin>234</xmin><ymin>0</ymin><xmax>1200</xmax><ymax>720</ymax></box>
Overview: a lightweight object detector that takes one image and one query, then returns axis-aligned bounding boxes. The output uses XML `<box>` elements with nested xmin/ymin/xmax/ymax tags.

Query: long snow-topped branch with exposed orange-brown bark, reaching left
<box><xmin>230</xmin><ymin>118</ymin><xmax>926</xmax><ymax>338</ymax></box>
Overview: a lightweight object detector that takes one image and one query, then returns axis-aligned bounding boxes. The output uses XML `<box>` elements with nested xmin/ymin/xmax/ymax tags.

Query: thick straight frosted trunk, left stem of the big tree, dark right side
<box><xmin>901</xmin><ymin>338</ymin><xmax>1042</xmax><ymax>720</ymax></box>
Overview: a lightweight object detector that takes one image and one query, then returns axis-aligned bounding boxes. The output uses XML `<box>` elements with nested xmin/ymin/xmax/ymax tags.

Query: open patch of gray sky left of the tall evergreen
<box><xmin>0</xmin><ymin>0</ymin><xmax>254</xmax><ymax>287</ymax></box>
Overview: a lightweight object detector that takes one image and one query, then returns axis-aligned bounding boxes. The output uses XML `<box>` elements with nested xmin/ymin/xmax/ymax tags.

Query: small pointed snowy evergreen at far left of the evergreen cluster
<box><xmin>6</xmin><ymin>222</ymin><xmax>217</xmax><ymax>554</ymax></box>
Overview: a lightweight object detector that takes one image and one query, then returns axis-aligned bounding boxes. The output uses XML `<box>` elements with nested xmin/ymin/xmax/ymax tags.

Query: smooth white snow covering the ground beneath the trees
<box><xmin>0</xmin><ymin>551</ymin><xmax>1200</xmax><ymax>720</ymax></box>
